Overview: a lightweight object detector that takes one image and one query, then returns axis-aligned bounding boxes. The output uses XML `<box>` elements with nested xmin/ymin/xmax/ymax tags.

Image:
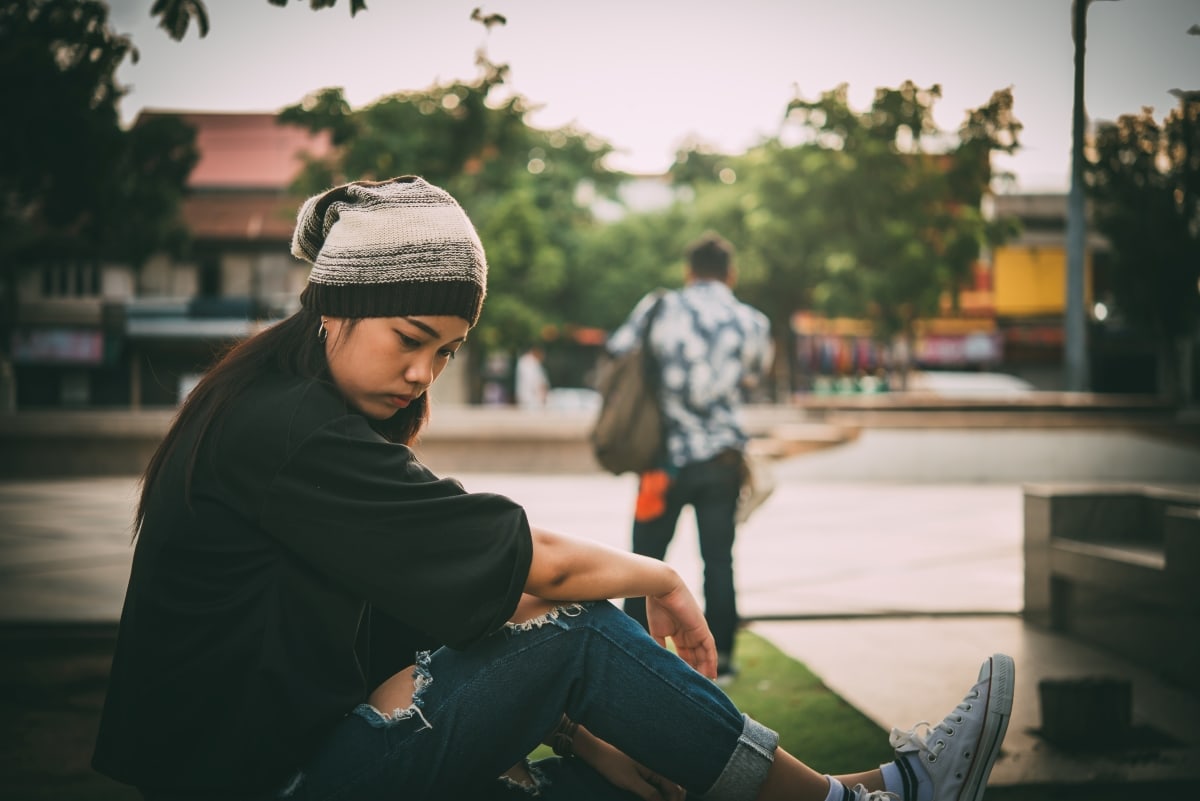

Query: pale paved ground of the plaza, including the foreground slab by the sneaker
<box><xmin>0</xmin><ymin>472</ymin><xmax>1200</xmax><ymax>785</ymax></box>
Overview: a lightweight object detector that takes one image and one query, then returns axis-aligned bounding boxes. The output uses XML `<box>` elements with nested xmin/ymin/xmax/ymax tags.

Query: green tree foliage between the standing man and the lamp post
<box><xmin>573</xmin><ymin>83</ymin><xmax>1021</xmax><ymax>393</ymax></box>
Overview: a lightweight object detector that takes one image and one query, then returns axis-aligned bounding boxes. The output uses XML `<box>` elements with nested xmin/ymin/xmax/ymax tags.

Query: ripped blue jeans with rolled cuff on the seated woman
<box><xmin>277</xmin><ymin>602</ymin><xmax>779</xmax><ymax>801</ymax></box>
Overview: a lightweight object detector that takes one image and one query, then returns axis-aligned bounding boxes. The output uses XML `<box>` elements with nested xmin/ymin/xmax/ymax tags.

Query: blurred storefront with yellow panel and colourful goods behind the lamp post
<box><xmin>791</xmin><ymin>194</ymin><xmax>1154</xmax><ymax>392</ymax></box>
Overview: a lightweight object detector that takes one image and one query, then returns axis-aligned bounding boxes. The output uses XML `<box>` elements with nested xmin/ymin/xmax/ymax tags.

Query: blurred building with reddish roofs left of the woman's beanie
<box><xmin>11</xmin><ymin>110</ymin><xmax>330</xmax><ymax>408</ymax></box>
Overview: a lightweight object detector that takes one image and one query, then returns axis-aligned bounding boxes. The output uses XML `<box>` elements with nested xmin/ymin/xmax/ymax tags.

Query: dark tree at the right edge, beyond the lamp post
<box><xmin>1086</xmin><ymin>100</ymin><xmax>1200</xmax><ymax>402</ymax></box>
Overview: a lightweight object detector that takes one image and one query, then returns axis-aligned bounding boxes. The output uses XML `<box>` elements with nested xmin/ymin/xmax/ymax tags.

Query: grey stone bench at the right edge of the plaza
<box><xmin>1024</xmin><ymin>484</ymin><xmax>1200</xmax><ymax>689</ymax></box>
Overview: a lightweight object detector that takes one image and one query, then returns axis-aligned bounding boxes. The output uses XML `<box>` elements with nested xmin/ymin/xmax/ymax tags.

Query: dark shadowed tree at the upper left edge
<box><xmin>0</xmin><ymin>0</ymin><xmax>197</xmax><ymax>340</ymax></box>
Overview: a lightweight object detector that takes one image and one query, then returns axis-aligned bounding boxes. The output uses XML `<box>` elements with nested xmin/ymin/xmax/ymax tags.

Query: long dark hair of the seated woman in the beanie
<box><xmin>133</xmin><ymin>308</ymin><xmax>430</xmax><ymax>537</ymax></box>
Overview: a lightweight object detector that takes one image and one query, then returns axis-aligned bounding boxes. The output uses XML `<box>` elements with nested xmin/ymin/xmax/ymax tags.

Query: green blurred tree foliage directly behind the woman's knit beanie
<box><xmin>280</xmin><ymin>48</ymin><xmax>620</xmax><ymax>349</ymax></box>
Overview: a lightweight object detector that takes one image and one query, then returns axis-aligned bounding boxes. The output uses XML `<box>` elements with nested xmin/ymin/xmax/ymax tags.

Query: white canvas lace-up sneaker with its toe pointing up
<box><xmin>890</xmin><ymin>654</ymin><xmax>1015</xmax><ymax>801</ymax></box>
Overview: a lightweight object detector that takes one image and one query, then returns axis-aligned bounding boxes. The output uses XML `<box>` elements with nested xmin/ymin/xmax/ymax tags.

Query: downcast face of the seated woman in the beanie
<box><xmin>322</xmin><ymin>315</ymin><xmax>470</xmax><ymax>420</ymax></box>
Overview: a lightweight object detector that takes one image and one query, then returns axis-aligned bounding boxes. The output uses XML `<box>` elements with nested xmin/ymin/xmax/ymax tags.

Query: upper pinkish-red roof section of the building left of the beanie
<box><xmin>134</xmin><ymin>110</ymin><xmax>332</xmax><ymax>189</ymax></box>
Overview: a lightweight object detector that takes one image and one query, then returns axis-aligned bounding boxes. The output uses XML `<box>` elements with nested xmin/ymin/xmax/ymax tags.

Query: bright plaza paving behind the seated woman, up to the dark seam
<box><xmin>0</xmin><ymin>474</ymin><xmax>1021</xmax><ymax>622</ymax></box>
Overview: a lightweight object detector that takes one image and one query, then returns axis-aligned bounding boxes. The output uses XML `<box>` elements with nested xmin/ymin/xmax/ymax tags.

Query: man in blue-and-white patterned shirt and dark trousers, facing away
<box><xmin>608</xmin><ymin>234</ymin><xmax>772</xmax><ymax>683</ymax></box>
